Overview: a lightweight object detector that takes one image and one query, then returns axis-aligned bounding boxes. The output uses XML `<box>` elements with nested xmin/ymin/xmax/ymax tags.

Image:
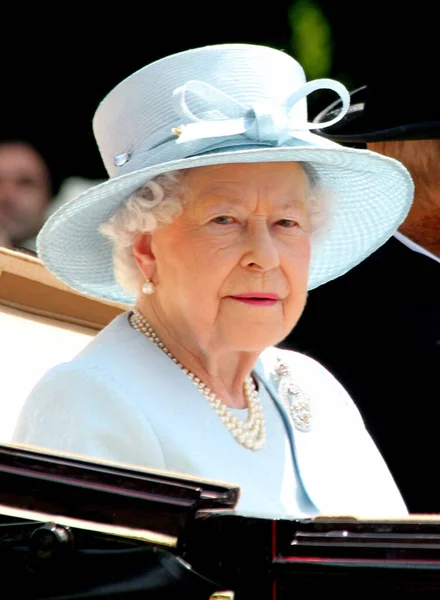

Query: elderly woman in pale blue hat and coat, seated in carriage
<box><xmin>14</xmin><ymin>44</ymin><xmax>413</xmax><ymax>517</ymax></box>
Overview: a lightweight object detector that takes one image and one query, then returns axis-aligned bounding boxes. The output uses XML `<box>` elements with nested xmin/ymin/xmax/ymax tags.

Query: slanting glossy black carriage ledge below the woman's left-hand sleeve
<box><xmin>0</xmin><ymin>446</ymin><xmax>239</xmax><ymax>536</ymax></box>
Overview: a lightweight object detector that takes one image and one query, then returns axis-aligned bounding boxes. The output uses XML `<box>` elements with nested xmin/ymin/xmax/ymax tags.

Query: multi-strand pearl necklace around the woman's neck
<box><xmin>129</xmin><ymin>310</ymin><xmax>266</xmax><ymax>450</ymax></box>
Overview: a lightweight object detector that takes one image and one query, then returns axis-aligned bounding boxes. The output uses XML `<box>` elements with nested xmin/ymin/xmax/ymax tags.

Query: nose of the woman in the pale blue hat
<box><xmin>241</xmin><ymin>220</ymin><xmax>280</xmax><ymax>272</ymax></box>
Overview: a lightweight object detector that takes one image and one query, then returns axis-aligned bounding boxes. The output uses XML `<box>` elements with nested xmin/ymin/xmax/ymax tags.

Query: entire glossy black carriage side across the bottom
<box><xmin>0</xmin><ymin>447</ymin><xmax>440</xmax><ymax>600</ymax></box>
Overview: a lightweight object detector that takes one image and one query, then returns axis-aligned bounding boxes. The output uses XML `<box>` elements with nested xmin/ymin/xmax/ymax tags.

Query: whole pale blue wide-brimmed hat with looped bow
<box><xmin>37</xmin><ymin>44</ymin><xmax>413</xmax><ymax>304</ymax></box>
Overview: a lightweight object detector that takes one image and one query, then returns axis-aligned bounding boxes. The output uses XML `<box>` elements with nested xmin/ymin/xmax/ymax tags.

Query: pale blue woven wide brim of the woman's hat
<box><xmin>37</xmin><ymin>142</ymin><xmax>413</xmax><ymax>304</ymax></box>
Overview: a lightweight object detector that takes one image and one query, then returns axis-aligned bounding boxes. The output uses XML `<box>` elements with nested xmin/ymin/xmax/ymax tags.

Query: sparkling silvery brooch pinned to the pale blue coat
<box><xmin>275</xmin><ymin>358</ymin><xmax>312</xmax><ymax>432</ymax></box>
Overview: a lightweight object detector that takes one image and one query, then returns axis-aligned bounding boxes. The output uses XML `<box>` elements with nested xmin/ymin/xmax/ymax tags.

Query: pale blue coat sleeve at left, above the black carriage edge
<box><xmin>12</xmin><ymin>359</ymin><xmax>164</xmax><ymax>468</ymax></box>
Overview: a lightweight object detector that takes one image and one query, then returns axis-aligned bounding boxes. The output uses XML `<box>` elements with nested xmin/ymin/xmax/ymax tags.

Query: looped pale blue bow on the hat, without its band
<box><xmin>173</xmin><ymin>79</ymin><xmax>350</xmax><ymax>145</ymax></box>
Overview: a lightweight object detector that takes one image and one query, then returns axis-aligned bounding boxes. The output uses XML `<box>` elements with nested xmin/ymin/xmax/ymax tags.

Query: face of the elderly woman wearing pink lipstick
<box><xmin>143</xmin><ymin>163</ymin><xmax>310</xmax><ymax>352</ymax></box>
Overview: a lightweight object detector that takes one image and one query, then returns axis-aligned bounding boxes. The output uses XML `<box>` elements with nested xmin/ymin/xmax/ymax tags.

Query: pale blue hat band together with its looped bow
<box><xmin>113</xmin><ymin>79</ymin><xmax>350</xmax><ymax>174</ymax></box>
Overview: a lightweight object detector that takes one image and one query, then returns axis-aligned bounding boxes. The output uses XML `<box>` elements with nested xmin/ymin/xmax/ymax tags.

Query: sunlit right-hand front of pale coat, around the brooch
<box><xmin>255</xmin><ymin>348</ymin><xmax>406</xmax><ymax>516</ymax></box>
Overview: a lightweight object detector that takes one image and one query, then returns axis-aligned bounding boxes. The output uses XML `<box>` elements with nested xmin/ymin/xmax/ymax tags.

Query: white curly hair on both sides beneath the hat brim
<box><xmin>100</xmin><ymin>162</ymin><xmax>330</xmax><ymax>296</ymax></box>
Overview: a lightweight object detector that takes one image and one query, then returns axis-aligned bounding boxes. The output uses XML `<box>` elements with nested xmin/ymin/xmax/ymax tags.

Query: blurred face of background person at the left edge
<box><xmin>0</xmin><ymin>143</ymin><xmax>49</xmax><ymax>244</ymax></box>
